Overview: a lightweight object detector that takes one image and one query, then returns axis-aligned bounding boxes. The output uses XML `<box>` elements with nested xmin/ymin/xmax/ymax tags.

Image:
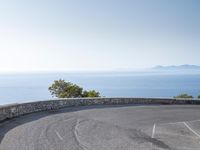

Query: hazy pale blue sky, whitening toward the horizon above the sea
<box><xmin>0</xmin><ymin>0</ymin><xmax>200</xmax><ymax>71</ymax></box>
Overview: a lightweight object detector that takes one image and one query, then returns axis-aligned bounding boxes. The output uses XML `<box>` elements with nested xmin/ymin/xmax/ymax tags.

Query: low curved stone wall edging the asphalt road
<box><xmin>0</xmin><ymin>98</ymin><xmax>200</xmax><ymax>121</ymax></box>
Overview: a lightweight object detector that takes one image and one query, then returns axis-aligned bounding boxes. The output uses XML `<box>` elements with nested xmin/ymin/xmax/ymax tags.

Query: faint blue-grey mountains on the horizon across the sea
<box><xmin>153</xmin><ymin>64</ymin><xmax>200</xmax><ymax>71</ymax></box>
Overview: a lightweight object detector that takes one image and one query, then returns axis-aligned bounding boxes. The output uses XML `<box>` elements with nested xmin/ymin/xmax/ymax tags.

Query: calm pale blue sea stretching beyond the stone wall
<box><xmin>0</xmin><ymin>73</ymin><xmax>200</xmax><ymax>105</ymax></box>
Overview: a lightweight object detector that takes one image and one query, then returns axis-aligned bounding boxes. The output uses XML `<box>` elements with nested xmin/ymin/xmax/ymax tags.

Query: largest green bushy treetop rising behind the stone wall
<box><xmin>49</xmin><ymin>79</ymin><xmax>100</xmax><ymax>98</ymax></box>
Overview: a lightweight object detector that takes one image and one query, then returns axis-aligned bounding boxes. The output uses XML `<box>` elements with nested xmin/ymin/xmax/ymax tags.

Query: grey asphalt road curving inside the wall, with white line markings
<box><xmin>0</xmin><ymin>105</ymin><xmax>200</xmax><ymax>150</ymax></box>
